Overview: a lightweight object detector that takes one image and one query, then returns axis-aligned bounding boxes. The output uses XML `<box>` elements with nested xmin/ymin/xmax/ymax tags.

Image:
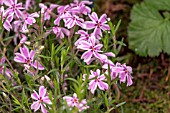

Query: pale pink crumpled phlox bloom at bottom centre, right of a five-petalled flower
<box><xmin>63</xmin><ymin>93</ymin><xmax>89</xmax><ymax>112</ymax></box>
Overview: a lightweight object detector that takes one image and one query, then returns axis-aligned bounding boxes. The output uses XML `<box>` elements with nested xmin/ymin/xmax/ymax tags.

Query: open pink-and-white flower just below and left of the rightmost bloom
<box><xmin>84</xmin><ymin>69</ymin><xmax>108</xmax><ymax>94</ymax></box>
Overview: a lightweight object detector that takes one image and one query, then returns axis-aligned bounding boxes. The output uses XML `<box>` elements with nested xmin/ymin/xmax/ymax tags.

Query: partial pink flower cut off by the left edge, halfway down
<box><xmin>0</xmin><ymin>57</ymin><xmax>13</xmax><ymax>79</ymax></box>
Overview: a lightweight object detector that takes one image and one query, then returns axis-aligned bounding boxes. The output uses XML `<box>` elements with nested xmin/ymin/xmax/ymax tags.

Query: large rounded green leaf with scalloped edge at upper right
<box><xmin>128</xmin><ymin>0</ymin><xmax>170</xmax><ymax>57</ymax></box>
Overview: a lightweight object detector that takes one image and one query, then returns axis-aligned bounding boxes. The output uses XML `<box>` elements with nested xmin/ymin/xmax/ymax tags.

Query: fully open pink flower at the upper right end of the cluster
<box><xmin>86</xmin><ymin>12</ymin><xmax>110</xmax><ymax>39</ymax></box>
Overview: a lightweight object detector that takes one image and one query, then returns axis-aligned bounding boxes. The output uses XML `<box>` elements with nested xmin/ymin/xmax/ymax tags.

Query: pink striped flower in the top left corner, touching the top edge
<box><xmin>4</xmin><ymin>0</ymin><xmax>24</xmax><ymax>18</ymax></box>
